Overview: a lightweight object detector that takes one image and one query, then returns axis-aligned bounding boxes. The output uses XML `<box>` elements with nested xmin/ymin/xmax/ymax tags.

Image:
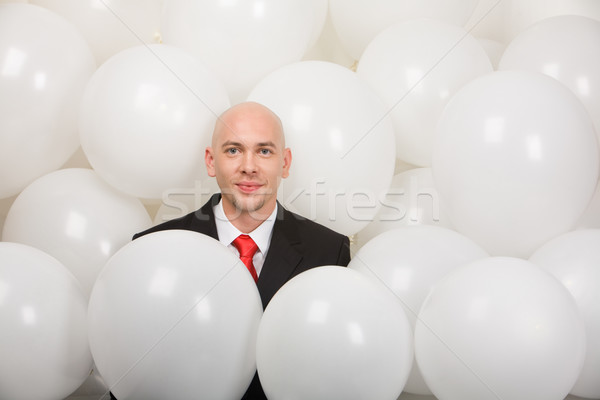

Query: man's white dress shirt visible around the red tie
<box><xmin>213</xmin><ymin>199</ymin><xmax>277</xmax><ymax>275</ymax></box>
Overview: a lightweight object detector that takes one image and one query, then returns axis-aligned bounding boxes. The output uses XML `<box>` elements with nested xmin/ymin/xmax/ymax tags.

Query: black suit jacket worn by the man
<box><xmin>127</xmin><ymin>194</ymin><xmax>350</xmax><ymax>400</ymax></box>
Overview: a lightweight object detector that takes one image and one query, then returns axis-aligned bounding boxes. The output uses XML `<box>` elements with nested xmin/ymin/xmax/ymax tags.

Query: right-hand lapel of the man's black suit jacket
<box><xmin>258</xmin><ymin>203</ymin><xmax>303</xmax><ymax>307</ymax></box>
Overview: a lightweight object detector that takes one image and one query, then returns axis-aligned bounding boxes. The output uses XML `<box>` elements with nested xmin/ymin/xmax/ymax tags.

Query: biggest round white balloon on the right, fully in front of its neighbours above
<box><xmin>432</xmin><ymin>71</ymin><xmax>598</xmax><ymax>257</ymax></box>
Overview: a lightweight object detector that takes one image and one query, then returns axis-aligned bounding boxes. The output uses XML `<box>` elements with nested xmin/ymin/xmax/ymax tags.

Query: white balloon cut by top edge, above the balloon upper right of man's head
<box><xmin>329</xmin><ymin>0</ymin><xmax>477</xmax><ymax>60</ymax></box>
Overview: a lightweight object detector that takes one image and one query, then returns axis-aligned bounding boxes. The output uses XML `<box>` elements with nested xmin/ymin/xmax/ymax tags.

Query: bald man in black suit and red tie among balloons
<box><xmin>129</xmin><ymin>102</ymin><xmax>350</xmax><ymax>400</ymax></box>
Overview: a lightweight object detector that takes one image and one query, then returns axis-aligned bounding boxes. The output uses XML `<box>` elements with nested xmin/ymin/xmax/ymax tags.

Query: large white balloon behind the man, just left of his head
<box><xmin>80</xmin><ymin>45</ymin><xmax>229</xmax><ymax>199</ymax></box>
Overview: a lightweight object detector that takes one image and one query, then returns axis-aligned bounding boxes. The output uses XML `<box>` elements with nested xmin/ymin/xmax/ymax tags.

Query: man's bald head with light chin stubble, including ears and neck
<box><xmin>205</xmin><ymin>107</ymin><xmax>291</xmax><ymax>218</ymax></box>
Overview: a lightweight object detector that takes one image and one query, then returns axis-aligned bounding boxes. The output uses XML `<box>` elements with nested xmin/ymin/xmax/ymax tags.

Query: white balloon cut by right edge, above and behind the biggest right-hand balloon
<box><xmin>499</xmin><ymin>15</ymin><xmax>600</xmax><ymax>138</ymax></box>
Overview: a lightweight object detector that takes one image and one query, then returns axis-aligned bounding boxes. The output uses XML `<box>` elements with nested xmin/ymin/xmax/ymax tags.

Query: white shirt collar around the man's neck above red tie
<box><xmin>213</xmin><ymin>199</ymin><xmax>277</xmax><ymax>254</ymax></box>
